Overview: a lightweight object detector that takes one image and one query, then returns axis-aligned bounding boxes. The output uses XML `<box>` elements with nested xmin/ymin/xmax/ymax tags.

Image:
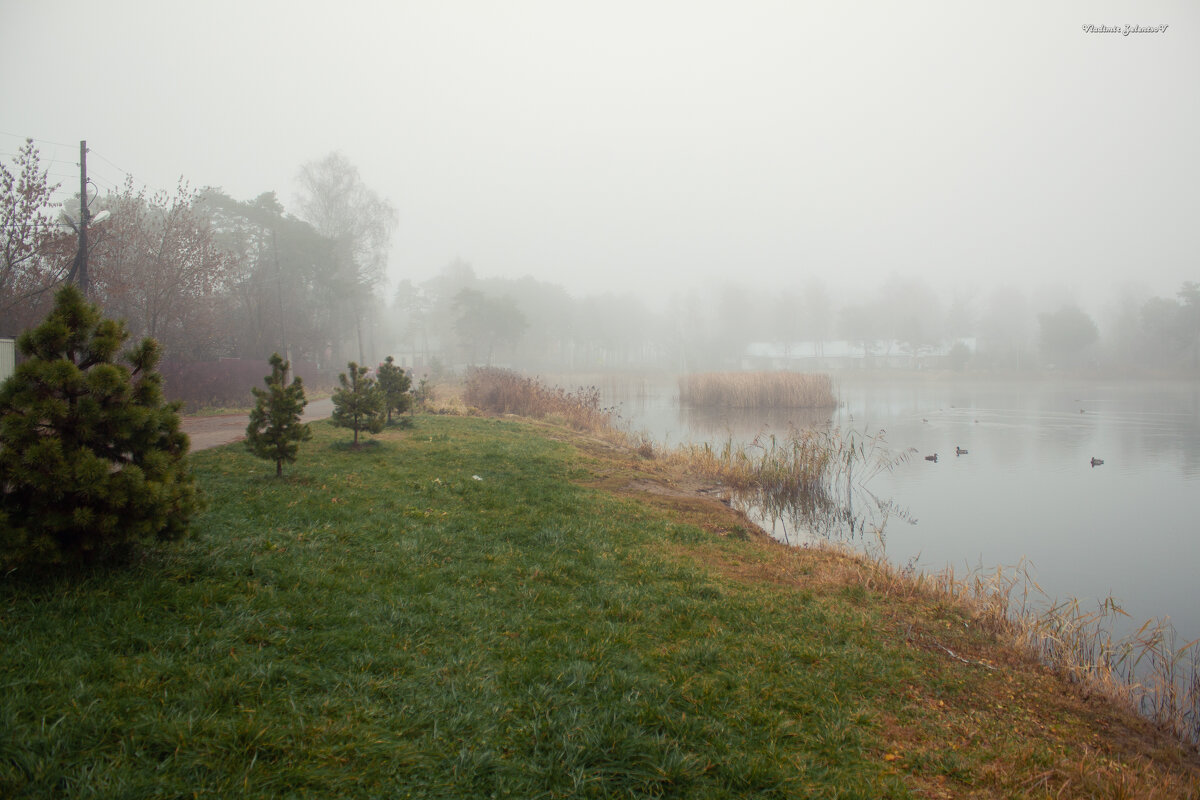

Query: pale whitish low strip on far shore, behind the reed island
<box><xmin>742</xmin><ymin>338</ymin><xmax>976</xmax><ymax>371</ymax></box>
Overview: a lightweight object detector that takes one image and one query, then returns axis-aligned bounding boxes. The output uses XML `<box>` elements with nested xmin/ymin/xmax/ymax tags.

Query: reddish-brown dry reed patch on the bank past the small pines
<box><xmin>462</xmin><ymin>367</ymin><xmax>617</xmax><ymax>433</ymax></box>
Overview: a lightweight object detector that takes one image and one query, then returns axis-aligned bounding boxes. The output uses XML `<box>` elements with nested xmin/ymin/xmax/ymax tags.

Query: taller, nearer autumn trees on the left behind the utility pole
<box><xmin>0</xmin><ymin>140</ymin><xmax>396</xmax><ymax>371</ymax></box>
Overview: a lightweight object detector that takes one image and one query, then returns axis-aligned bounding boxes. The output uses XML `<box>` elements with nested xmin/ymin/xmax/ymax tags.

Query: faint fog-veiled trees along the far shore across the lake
<box><xmin>378</xmin><ymin>261</ymin><xmax>1200</xmax><ymax>374</ymax></box>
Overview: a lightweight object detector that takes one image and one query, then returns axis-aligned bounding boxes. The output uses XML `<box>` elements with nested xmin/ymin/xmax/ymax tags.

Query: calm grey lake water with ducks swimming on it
<box><xmin>605</xmin><ymin>375</ymin><xmax>1200</xmax><ymax>644</ymax></box>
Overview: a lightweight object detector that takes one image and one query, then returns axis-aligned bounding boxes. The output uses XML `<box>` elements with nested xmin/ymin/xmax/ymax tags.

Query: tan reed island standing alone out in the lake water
<box><xmin>679</xmin><ymin>372</ymin><xmax>838</xmax><ymax>409</ymax></box>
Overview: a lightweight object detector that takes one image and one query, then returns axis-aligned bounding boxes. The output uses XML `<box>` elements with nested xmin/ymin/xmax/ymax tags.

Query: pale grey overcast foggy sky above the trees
<box><xmin>0</xmin><ymin>0</ymin><xmax>1200</xmax><ymax>302</ymax></box>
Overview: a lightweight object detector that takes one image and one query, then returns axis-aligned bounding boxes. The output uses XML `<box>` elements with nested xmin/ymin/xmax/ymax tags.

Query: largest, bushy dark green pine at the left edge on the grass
<box><xmin>0</xmin><ymin>285</ymin><xmax>198</xmax><ymax>569</ymax></box>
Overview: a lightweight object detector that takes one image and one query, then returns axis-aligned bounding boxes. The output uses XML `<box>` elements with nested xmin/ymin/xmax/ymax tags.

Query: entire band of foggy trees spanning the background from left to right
<box><xmin>0</xmin><ymin>140</ymin><xmax>1200</xmax><ymax>374</ymax></box>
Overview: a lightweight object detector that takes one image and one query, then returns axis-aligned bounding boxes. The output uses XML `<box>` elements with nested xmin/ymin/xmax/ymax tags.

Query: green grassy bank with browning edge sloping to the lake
<box><xmin>0</xmin><ymin>416</ymin><xmax>1200</xmax><ymax>798</ymax></box>
